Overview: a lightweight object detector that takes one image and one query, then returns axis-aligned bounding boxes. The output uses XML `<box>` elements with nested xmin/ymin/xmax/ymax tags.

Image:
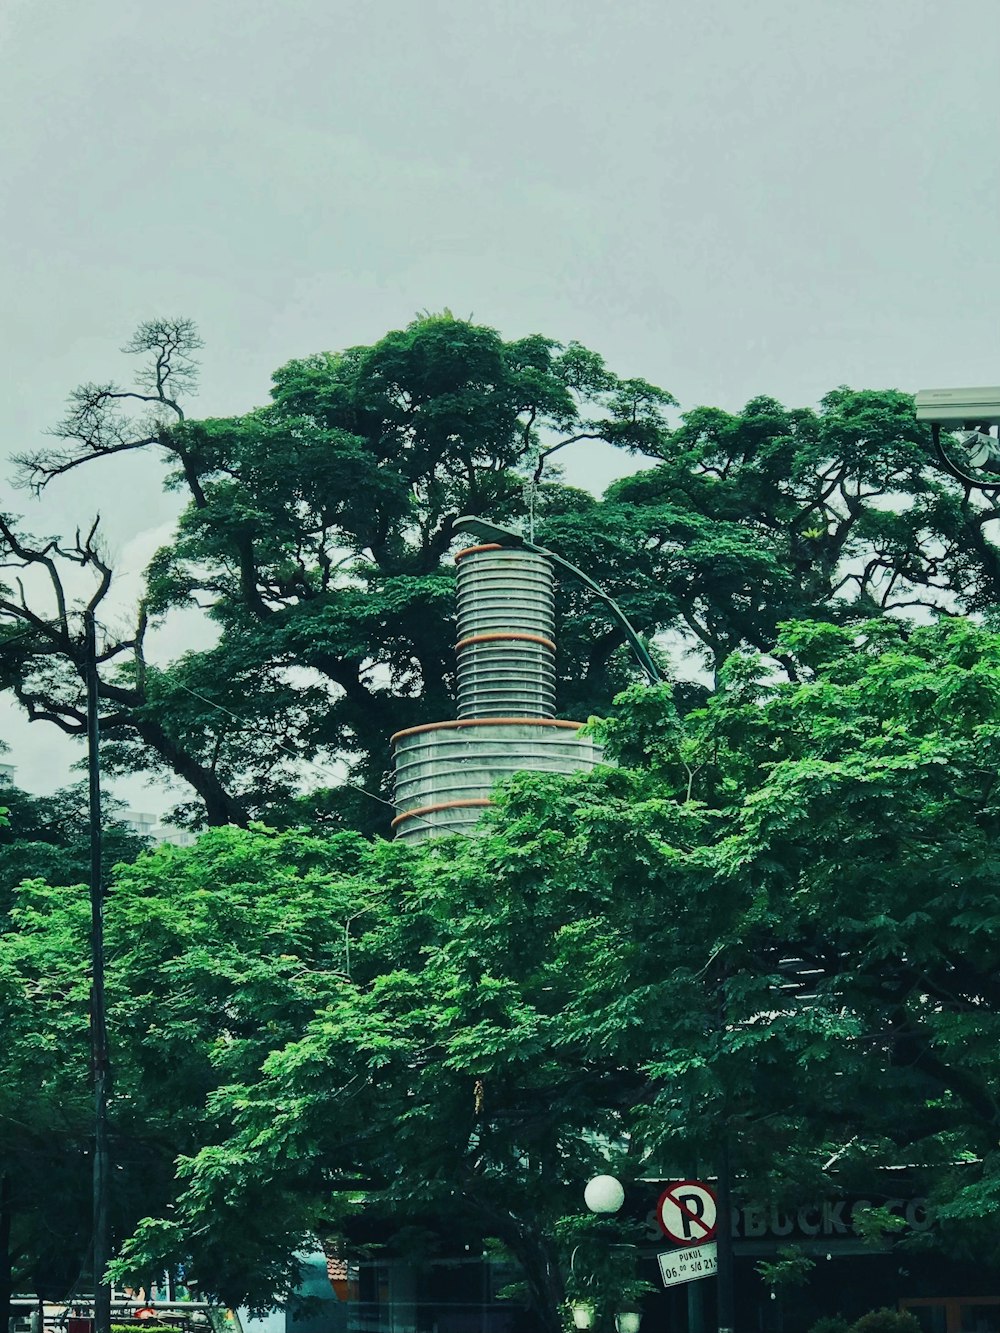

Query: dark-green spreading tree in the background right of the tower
<box><xmin>541</xmin><ymin>388</ymin><xmax>1000</xmax><ymax>710</ymax></box>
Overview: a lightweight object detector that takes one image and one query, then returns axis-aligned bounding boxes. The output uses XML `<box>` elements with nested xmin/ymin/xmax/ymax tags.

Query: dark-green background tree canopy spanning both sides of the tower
<box><xmin>0</xmin><ymin>312</ymin><xmax>1000</xmax><ymax>830</ymax></box>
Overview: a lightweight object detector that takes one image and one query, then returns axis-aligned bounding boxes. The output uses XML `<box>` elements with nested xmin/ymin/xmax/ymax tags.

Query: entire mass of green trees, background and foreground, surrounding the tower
<box><xmin>0</xmin><ymin>315</ymin><xmax>1000</xmax><ymax>1329</ymax></box>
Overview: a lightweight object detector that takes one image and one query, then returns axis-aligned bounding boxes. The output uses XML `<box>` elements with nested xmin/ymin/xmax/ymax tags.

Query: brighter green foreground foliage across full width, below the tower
<box><xmin>0</xmin><ymin>620</ymin><xmax>1000</xmax><ymax>1326</ymax></box>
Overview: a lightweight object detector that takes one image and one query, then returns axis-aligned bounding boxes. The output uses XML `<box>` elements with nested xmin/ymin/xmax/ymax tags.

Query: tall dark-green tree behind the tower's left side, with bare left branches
<box><xmin>0</xmin><ymin>313</ymin><xmax>673</xmax><ymax>825</ymax></box>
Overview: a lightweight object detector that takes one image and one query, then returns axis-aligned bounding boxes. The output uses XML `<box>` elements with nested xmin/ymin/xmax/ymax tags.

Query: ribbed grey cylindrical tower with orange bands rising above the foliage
<box><xmin>392</xmin><ymin>544</ymin><xmax>600</xmax><ymax>841</ymax></box>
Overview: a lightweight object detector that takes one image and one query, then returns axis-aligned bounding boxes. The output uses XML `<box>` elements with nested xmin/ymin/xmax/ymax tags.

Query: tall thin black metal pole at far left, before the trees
<box><xmin>84</xmin><ymin>611</ymin><xmax>111</xmax><ymax>1333</ymax></box>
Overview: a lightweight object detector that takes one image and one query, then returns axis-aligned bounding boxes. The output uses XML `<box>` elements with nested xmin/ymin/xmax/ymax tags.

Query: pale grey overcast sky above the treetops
<box><xmin>0</xmin><ymin>0</ymin><xmax>1000</xmax><ymax>800</ymax></box>
